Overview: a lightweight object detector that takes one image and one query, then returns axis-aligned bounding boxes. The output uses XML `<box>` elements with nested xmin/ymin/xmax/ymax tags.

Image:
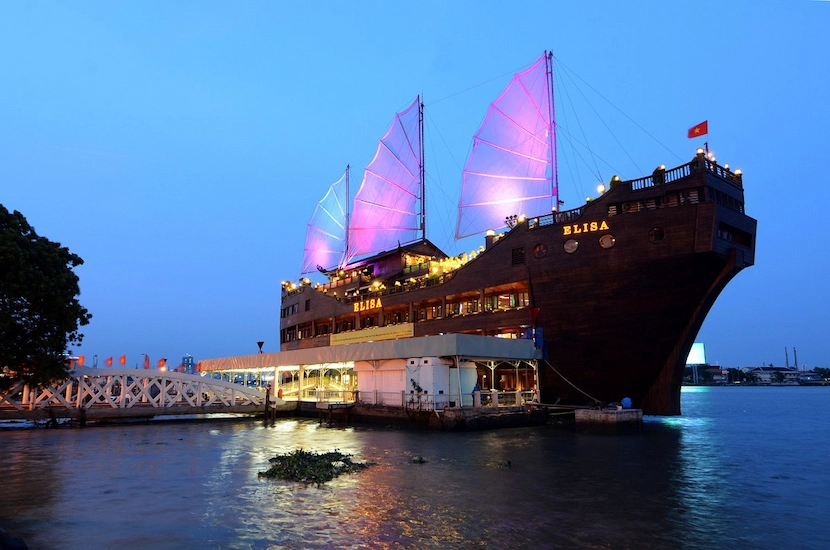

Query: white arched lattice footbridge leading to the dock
<box><xmin>0</xmin><ymin>367</ymin><xmax>296</xmax><ymax>421</ymax></box>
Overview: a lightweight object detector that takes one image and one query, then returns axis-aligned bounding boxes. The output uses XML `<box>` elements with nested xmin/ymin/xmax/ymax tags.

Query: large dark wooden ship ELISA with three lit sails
<box><xmin>280</xmin><ymin>53</ymin><xmax>756</xmax><ymax>415</ymax></box>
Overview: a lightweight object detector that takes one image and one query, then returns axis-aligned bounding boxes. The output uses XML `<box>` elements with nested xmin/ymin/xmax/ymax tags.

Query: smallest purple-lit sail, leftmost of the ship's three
<box><xmin>302</xmin><ymin>166</ymin><xmax>349</xmax><ymax>274</ymax></box>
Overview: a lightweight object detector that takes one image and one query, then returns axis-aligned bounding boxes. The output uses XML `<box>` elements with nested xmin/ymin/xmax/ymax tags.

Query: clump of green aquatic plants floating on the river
<box><xmin>259</xmin><ymin>449</ymin><xmax>371</xmax><ymax>485</ymax></box>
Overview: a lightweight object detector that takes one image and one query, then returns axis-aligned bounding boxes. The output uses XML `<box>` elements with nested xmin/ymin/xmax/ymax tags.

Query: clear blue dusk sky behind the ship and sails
<box><xmin>0</xmin><ymin>0</ymin><xmax>830</xmax><ymax>367</ymax></box>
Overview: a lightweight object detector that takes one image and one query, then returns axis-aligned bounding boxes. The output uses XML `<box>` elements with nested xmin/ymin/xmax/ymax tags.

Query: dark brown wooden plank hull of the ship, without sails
<box><xmin>281</xmin><ymin>154</ymin><xmax>756</xmax><ymax>415</ymax></box>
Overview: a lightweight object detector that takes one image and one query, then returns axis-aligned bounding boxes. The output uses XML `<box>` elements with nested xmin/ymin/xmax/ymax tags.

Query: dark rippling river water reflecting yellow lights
<box><xmin>0</xmin><ymin>387</ymin><xmax>830</xmax><ymax>549</ymax></box>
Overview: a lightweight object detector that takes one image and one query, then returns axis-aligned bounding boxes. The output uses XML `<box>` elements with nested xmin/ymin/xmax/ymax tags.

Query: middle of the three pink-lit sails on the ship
<box><xmin>346</xmin><ymin>97</ymin><xmax>424</xmax><ymax>263</ymax></box>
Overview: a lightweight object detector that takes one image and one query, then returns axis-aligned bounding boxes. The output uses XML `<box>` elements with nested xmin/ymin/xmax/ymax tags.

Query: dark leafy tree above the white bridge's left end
<box><xmin>0</xmin><ymin>204</ymin><xmax>92</xmax><ymax>387</ymax></box>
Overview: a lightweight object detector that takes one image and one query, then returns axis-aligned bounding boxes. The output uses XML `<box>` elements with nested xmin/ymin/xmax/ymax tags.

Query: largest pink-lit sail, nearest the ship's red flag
<box><xmin>455</xmin><ymin>52</ymin><xmax>558</xmax><ymax>239</ymax></box>
